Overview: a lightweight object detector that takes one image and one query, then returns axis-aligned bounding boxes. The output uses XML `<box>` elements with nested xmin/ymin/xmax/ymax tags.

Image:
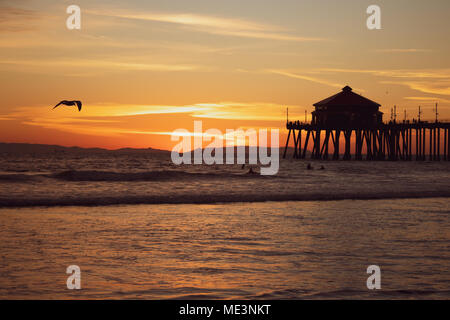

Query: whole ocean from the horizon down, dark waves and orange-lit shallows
<box><xmin>0</xmin><ymin>152</ymin><xmax>450</xmax><ymax>299</ymax></box>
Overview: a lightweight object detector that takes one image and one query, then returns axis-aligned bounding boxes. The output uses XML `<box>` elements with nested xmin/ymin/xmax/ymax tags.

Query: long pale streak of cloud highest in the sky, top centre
<box><xmin>88</xmin><ymin>11</ymin><xmax>324</xmax><ymax>42</ymax></box>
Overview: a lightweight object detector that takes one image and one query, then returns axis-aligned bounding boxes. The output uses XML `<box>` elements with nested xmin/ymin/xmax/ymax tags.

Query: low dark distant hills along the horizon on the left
<box><xmin>0</xmin><ymin>142</ymin><xmax>170</xmax><ymax>154</ymax></box>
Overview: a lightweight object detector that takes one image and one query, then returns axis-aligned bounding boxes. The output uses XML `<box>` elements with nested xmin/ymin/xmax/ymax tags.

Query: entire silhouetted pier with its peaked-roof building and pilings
<box><xmin>283</xmin><ymin>86</ymin><xmax>450</xmax><ymax>161</ymax></box>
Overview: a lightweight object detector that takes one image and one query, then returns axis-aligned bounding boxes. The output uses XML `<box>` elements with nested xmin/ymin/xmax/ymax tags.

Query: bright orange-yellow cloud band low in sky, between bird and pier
<box><xmin>4</xmin><ymin>102</ymin><xmax>303</xmax><ymax>136</ymax></box>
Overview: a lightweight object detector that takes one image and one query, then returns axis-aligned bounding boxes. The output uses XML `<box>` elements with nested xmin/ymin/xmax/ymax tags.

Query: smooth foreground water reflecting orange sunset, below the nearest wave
<box><xmin>0</xmin><ymin>198</ymin><xmax>450</xmax><ymax>299</ymax></box>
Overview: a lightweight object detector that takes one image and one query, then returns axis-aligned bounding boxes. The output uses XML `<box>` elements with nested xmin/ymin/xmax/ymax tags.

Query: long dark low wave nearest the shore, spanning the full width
<box><xmin>0</xmin><ymin>190</ymin><xmax>450</xmax><ymax>207</ymax></box>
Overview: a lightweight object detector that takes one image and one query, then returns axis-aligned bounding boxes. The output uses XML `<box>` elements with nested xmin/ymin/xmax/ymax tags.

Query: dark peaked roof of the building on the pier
<box><xmin>314</xmin><ymin>86</ymin><xmax>380</xmax><ymax>108</ymax></box>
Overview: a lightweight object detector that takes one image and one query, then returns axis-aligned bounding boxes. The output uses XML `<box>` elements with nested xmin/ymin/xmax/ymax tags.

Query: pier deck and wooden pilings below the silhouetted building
<box><xmin>283</xmin><ymin>121</ymin><xmax>450</xmax><ymax>161</ymax></box>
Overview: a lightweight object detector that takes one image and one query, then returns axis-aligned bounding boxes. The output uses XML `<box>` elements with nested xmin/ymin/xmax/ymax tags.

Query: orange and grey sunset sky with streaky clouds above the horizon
<box><xmin>0</xmin><ymin>0</ymin><xmax>450</xmax><ymax>150</ymax></box>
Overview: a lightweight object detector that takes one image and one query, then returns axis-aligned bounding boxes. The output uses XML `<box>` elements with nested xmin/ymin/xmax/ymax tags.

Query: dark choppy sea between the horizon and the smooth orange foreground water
<box><xmin>0</xmin><ymin>157</ymin><xmax>450</xmax><ymax>207</ymax></box>
